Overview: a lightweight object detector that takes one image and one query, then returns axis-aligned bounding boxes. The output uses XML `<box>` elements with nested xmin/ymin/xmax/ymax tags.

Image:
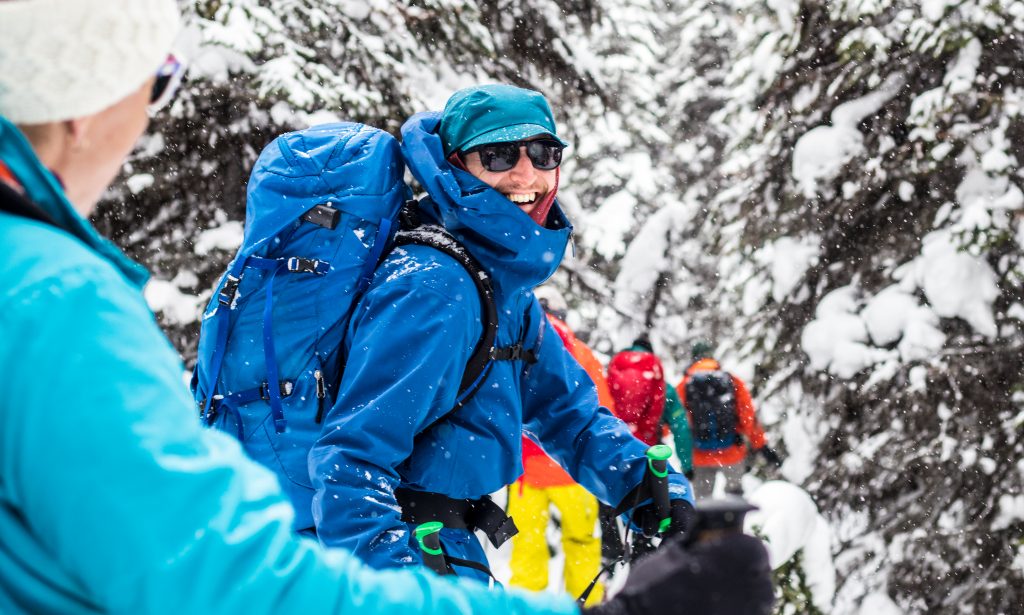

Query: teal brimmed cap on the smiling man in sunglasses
<box><xmin>439</xmin><ymin>84</ymin><xmax>567</xmax><ymax>156</ymax></box>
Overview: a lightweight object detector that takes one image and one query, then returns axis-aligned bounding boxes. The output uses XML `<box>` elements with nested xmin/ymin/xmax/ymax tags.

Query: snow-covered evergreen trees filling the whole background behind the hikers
<box><xmin>96</xmin><ymin>0</ymin><xmax>1024</xmax><ymax>615</ymax></box>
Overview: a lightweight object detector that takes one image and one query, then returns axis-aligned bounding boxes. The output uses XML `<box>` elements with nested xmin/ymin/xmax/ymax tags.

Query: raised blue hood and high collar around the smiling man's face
<box><xmin>401</xmin><ymin>112</ymin><xmax>572</xmax><ymax>295</ymax></box>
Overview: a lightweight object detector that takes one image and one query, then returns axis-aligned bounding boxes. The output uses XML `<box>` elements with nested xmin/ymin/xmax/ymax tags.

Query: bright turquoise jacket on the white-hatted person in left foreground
<box><xmin>0</xmin><ymin>118</ymin><xmax>577</xmax><ymax>615</ymax></box>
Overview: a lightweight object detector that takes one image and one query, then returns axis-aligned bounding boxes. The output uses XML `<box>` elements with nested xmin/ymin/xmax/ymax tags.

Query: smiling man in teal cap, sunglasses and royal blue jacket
<box><xmin>308</xmin><ymin>85</ymin><xmax>693</xmax><ymax>579</ymax></box>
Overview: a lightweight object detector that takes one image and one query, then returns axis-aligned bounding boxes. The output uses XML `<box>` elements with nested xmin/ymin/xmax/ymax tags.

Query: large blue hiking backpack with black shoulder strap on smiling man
<box><xmin>191</xmin><ymin>123</ymin><xmax>497</xmax><ymax>502</ymax></box>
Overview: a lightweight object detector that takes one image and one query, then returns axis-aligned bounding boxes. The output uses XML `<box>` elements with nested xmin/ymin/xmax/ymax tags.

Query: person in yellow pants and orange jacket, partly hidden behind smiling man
<box><xmin>508</xmin><ymin>287</ymin><xmax>613</xmax><ymax>606</ymax></box>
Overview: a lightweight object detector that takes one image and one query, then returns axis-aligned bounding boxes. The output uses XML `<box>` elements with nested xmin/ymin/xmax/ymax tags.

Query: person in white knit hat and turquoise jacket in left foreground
<box><xmin>0</xmin><ymin>0</ymin><xmax>578</xmax><ymax>615</ymax></box>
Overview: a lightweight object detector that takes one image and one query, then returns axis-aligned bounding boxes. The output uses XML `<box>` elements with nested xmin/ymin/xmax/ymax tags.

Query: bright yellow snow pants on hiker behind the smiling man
<box><xmin>508</xmin><ymin>483</ymin><xmax>604</xmax><ymax>606</ymax></box>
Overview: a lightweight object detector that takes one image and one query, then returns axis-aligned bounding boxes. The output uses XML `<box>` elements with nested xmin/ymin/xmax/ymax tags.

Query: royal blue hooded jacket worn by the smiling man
<box><xmin>309</xmin><ymin>114</ymin><xmax>692</xmax><ymax>568</ymax></box>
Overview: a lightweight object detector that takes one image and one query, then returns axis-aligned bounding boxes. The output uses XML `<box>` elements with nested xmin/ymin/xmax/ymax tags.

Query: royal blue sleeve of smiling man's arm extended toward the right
<box><xmin>523</xmin><ymin>301</ymin><xmax>693</xmax><ymax>507</ymax></box>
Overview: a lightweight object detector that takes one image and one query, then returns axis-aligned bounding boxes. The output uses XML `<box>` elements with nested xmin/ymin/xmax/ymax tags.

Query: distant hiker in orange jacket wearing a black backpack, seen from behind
<box><xmin>676</xmin><ymin>341</ymin><xmax>780</xmax><ymax>499</ymax></box>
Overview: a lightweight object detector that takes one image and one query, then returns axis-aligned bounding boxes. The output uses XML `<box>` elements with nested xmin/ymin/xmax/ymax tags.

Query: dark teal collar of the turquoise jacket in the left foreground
<box><xmin>0</xmin><ymin>116</ymin><xmax>150</xmax><ymax>289</ymax></box>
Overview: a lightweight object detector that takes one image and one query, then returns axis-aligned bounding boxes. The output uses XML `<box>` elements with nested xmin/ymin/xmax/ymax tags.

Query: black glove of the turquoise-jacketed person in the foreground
<box><xmin>585</xmin><ymin>533</ymin><xmax>775</xmax><ymax>615</ymax></box>
